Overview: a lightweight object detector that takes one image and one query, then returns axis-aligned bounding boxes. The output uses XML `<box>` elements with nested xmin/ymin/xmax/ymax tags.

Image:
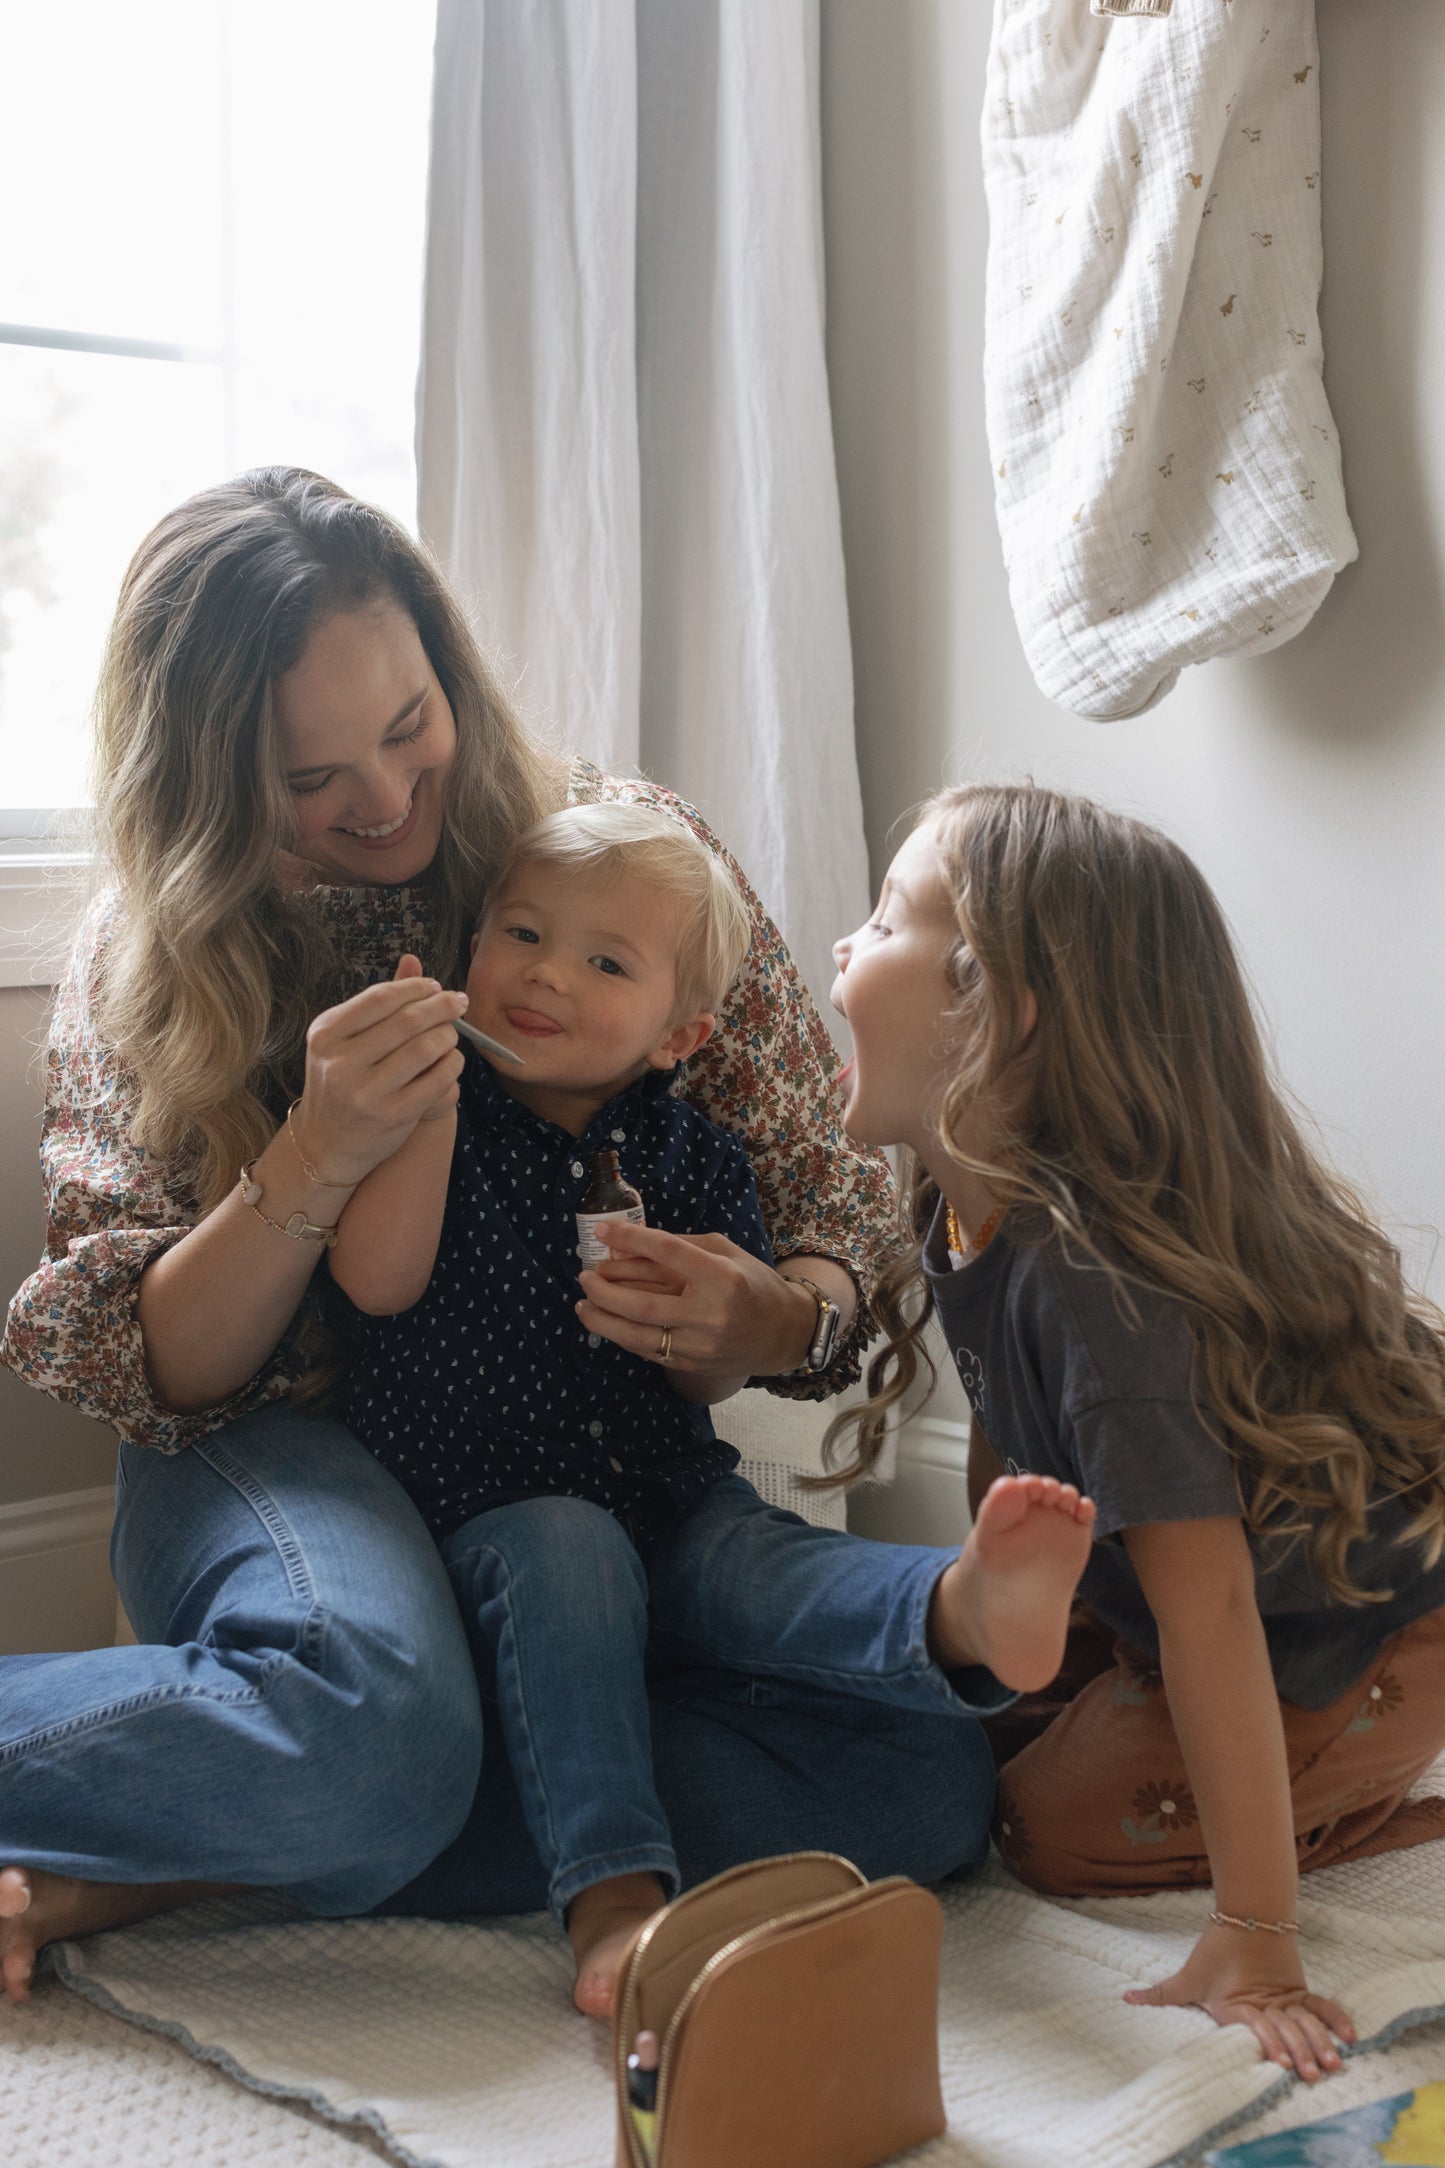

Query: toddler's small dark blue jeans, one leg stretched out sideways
<box><xmin>442</xmin><ymin>1476</ymin><xmax>1012</xmax><ymax>1919</ymax></box>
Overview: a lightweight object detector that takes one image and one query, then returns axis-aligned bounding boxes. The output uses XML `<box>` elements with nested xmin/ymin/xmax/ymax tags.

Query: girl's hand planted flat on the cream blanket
<box><xmin>1124</xmin><ymin>1923</ymin><xmax>1356</xmax><ymax>2086</ymax></box>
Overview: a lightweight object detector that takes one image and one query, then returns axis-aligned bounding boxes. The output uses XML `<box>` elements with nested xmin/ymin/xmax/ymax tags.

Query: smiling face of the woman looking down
<box><xmin>275</xmin><ymin>601</ymin><xmax>457</xmax><ymax>885</ymax></box>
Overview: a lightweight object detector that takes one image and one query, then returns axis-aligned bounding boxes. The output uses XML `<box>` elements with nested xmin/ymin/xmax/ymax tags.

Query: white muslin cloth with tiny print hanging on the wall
<box><xmin>984</xmin><ymin>0</ymin><xmax>1356</xmax><ymax>720</ymax></box>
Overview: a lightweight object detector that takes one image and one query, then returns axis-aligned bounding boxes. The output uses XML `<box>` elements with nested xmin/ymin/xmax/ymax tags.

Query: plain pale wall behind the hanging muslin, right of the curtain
<box><xmin>823</xmin><ymin>0</ymin><xmax>1445</xmax><ymax>1296</ymax></box>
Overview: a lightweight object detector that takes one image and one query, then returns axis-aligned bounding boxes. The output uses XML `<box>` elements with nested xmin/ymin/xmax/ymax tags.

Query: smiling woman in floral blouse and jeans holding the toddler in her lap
<box><xmin>0</xmin><ymin>468</ymin><xmax>992</xmax><ymax>1997</ymax></box>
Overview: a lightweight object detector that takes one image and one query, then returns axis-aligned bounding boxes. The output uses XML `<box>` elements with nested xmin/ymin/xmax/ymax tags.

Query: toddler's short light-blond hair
<box><xmin>494</xmin><ymin>800</ymin><xmax>752</xmax><ymax>1019</ymax></box>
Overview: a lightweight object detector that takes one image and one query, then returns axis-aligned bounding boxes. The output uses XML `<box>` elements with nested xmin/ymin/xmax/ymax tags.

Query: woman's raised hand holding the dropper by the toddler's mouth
<box><xmin>292</xmin><ymin>956</ymin><xmax>466</xmax><ymax>1188</ymax></box>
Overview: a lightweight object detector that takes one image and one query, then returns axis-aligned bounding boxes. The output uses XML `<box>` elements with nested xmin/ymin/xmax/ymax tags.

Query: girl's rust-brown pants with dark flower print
<box><xmin>986</xmin><ymin>1606</ymin><xmax>1445</xmax><ymax>1897</ymax></box>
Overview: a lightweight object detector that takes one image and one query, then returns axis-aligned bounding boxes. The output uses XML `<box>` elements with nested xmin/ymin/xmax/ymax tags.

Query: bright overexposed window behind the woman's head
<box><xmin>0</xmin><ymin>0</ymin><xmax>433</xmax><ymax>815</ymax></box>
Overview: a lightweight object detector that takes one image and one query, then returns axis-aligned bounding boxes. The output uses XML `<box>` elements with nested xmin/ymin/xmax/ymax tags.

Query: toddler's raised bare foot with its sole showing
<box><xmin>927</xmin><ymin>1476</ymin><xmax>1094</xmax><ymax>1693</ymax></box>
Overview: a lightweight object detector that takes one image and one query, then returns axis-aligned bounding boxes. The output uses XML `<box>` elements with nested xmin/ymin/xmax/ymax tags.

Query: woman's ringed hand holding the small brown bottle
<box><xmin>576</xmin><ymin>1221</ymin><xmax>817</xmax><ymax>1377</ymax></box>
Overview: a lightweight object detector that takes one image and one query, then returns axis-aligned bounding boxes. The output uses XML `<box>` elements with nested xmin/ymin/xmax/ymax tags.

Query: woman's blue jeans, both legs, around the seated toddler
<box><xmin>0</xmin><ymin>1405</ymin><xmax>992</xmax><ymax>1917</ymax></box>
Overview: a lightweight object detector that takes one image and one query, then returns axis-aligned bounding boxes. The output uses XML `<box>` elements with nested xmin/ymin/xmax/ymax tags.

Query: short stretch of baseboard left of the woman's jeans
<box><xmin>0</xmin><ymin>1483</ymin><xmax>115</xmax><ymax>1656</ymax></box>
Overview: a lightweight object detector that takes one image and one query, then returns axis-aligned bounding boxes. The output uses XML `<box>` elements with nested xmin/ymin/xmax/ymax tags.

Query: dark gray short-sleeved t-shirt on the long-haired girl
<box><xmin>923</xmin><ymin>1212</ymin><xmax>1445</xmax><ymax>1708</ymax></box>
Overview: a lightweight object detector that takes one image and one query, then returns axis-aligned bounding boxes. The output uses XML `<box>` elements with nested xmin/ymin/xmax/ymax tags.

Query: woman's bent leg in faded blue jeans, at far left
<box><xmin>0</xmin><ymin>1407</ymin><xmax>481</xmax><ymax>1912</ymax></box>
